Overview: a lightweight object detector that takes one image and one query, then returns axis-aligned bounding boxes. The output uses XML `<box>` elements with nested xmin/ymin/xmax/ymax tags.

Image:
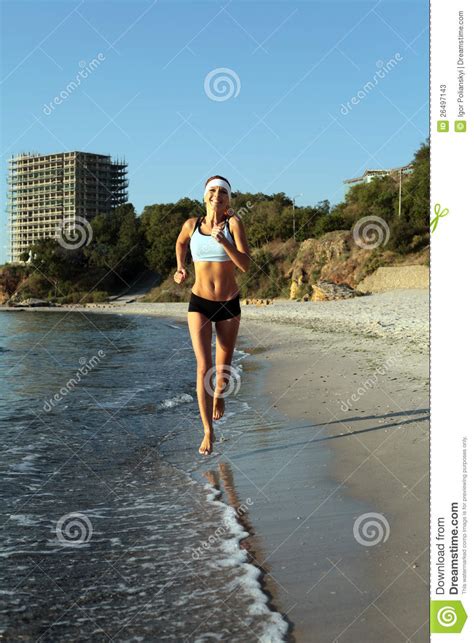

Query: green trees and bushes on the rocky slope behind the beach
<box><xmin>0</xmin><ymin>144</ymin><xmax>429</xmax><ymax>303</ymax></box>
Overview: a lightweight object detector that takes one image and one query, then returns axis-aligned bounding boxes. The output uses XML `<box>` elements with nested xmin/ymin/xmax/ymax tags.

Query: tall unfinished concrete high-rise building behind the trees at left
<box><xmin>7</xmin><ymin>152</ymin><xmax>128</xmax><ymax>262</ymax></box>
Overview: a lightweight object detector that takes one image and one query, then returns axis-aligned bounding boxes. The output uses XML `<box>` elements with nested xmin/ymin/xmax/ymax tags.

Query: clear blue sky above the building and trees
<box><xmin>0</xmin><ymin>0</ymin><xmax>429</xmax><ymax>262</ymax></box>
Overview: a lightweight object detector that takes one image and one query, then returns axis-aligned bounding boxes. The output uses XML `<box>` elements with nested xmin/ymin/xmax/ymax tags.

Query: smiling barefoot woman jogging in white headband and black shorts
<box><xmin>174</xmin><ymin>176</ymin><xmax>250</xmax><ymax>455</ymax></box>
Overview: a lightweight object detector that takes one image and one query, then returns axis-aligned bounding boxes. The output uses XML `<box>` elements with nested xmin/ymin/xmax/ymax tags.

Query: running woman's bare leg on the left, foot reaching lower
<box><xmin>188</xmin><ymin>312</ymin><xmax>213</xmax><ymax>455</ymax></box>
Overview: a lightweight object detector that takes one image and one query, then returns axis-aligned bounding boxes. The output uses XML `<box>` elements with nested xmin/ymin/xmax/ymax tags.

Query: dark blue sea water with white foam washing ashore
<box><xmin>0</xmin><ymin>311</ymin><xmax>286</xmax><ymax>641</ymax></box>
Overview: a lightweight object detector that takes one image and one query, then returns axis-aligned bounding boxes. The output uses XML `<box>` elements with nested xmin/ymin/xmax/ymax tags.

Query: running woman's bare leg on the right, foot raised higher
<box><xmin>212</xmin><ymin>315</ymin><xmax>240</xmax><ymax>420</ymax></box>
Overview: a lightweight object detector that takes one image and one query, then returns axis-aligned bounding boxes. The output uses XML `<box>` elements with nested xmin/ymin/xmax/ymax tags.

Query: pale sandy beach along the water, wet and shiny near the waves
<box><xmin>0</xmin><ymin>290</ymin><xmax>429</xmax><ymax>643</ymax></box>
